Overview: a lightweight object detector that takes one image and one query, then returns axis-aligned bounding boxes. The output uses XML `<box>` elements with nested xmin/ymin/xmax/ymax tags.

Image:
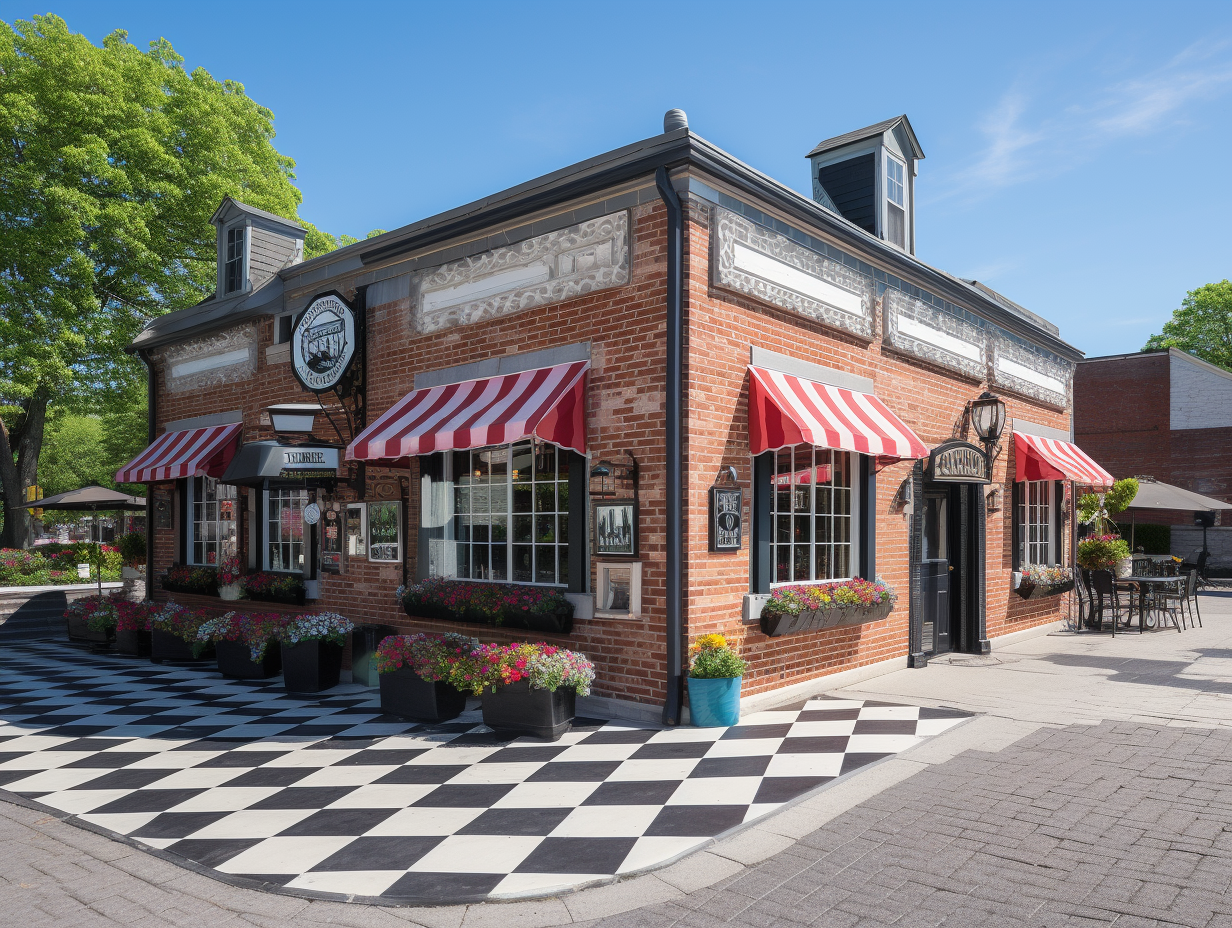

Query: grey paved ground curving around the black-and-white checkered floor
<box><xmin>0</xmin><ymin>596</ymin><xmax>1232</xmax><ymax>928</ymax></box>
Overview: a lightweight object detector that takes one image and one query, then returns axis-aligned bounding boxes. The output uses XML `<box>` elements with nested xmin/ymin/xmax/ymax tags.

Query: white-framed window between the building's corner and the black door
<box><xmin>768</xmin><ymin>445</ymin><xmax>860</xmax><ymax>583</ymax></box>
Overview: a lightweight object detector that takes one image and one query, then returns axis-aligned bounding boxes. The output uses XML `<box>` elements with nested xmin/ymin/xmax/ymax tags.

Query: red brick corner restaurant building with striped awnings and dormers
<box><xmin>115</xmin><ymin>111</ymin><xmax>1098</xmax><ymax>718</ymax></box>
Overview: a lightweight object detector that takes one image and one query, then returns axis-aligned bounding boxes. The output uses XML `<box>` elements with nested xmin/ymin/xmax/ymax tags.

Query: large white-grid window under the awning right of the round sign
<box><xmin>426</xmin><ymin>441</ymin><xmax>570</xmax><ymax>585</ymax></box>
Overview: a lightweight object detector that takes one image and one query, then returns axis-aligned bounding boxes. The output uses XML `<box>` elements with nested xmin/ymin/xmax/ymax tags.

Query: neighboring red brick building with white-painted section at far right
<box><xmin>1074</xmin><ymin>348</ymin><xmax>1232</xmax><ymax>567</ymax></box>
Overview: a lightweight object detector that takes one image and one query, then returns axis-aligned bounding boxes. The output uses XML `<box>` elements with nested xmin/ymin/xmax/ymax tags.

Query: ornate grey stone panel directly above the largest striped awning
<box><xmin>411</xmin><ymin>211</ymin><xmax>630</xmax><ymax>334</ymax></box>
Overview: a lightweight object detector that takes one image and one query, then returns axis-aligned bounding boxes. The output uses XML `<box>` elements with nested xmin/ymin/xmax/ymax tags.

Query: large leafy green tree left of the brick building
<box><xmin>0</xmin><ymin>16</ymin><xmax>312</xmax><ymax>546</ymax></box>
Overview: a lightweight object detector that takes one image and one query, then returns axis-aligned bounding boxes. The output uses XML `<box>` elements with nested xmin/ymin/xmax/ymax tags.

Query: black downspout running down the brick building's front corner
<box><xmin>654</xmin><ymin>168</ymin><xmax>684</xmax><ymax>725</ymax></box>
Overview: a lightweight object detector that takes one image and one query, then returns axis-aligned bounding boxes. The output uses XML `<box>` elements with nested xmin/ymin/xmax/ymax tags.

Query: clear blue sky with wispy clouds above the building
<box><xmin>12</xmin><ymin>0</ymin><xmax>1232</xmax><ymax>355</ymax></box>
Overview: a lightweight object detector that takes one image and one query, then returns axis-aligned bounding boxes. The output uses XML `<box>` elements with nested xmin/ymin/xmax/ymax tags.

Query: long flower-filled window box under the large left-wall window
<box><xmin>399</xmin><ymin>578</ymin><xmax>573</xmax><ymax>635</ymax></box>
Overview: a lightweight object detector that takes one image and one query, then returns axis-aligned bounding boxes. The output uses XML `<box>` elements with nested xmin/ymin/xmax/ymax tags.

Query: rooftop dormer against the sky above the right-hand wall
<box><xmin>807</xmin><ymin>116</ymin><xmax>924</xmax><ymax>254</ymax></box>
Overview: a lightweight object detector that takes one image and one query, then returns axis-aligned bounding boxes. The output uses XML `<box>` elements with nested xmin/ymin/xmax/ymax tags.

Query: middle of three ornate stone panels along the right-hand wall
<box><xmin>881</xmin><ymin>288</ymin><xmax>988</xmax><ymax>380</ymax></box>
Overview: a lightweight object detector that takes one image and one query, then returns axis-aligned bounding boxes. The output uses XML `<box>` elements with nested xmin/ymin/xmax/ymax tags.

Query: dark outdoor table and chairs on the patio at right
<box><xmin>1076</xmin><ymin>555</ymin><xmax>1202</xmax><ymax>637</ymax></box>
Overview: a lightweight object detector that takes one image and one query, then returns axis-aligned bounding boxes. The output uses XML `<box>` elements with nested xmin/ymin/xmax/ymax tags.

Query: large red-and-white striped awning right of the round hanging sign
<box><xmin>346</xmin><ymin>361</ymin><xmax>590</xmax><ymax>461</ymax></box>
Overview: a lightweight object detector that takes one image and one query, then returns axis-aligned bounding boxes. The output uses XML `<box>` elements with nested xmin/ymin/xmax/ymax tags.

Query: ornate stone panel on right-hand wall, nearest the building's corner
<box><xmin>711</xmin><ymin>208</ymin><xmax>876</xmax><ymax>338</ymax></box>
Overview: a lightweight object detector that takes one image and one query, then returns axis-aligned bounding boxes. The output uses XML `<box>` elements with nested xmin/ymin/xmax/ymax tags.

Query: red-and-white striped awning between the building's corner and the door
<box><xmin>749</xmin><ymin>365</ymin><xmax>928</xmax><ymax>465</ymax></box>
